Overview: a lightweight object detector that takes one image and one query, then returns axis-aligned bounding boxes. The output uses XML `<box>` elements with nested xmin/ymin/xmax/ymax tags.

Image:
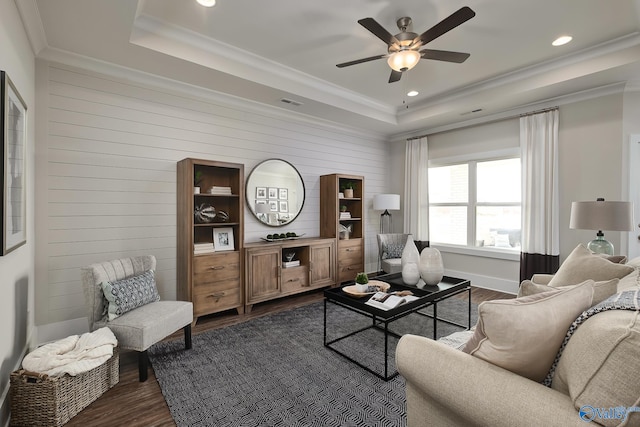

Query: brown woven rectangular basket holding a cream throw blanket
<box><xmin>10</xmin><ymin>347</ymin><xmax>120</xmax><ymax>427</ymax></box>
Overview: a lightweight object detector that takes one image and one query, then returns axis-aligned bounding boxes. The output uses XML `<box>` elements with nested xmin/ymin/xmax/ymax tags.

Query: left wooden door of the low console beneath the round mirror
<box><xmin>245</xmin><ymin>247</ymin><xmax>280</xmax><ymax>304</ymax></box>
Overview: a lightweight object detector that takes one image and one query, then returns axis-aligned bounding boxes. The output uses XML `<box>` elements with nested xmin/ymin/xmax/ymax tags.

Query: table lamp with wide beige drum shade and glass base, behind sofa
<box><xmin>569</xmin><ymin>198</ymin><xmax>633</xmax><ymax>255</ymax></box>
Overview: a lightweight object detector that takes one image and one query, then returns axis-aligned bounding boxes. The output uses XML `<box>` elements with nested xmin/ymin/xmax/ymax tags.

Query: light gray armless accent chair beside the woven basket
<box><xmin>81</xmin><ymin>255</ymin><xmax>193</xmax><ymax>382</ymax></box>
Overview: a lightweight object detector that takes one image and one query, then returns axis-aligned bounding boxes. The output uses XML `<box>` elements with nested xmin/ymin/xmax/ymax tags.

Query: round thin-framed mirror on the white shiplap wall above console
<box><xmin>245</xmin><ymin>159</ymin><xmax>304</xmax><ymax>227</ymax></box>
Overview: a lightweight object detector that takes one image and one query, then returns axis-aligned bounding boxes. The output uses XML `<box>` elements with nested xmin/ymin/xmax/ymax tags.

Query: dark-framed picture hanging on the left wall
<box><xmin>0</xmin><ymin>71</ymin><xmax>27</xmax><ymax>255</ymax></box>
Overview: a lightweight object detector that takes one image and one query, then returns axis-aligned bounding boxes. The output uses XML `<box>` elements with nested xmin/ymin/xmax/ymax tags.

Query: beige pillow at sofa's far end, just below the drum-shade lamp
<box><xmin>549</xmin><ymin>245</ymin><xmax>633</xmax><ymax>287</ymax></box>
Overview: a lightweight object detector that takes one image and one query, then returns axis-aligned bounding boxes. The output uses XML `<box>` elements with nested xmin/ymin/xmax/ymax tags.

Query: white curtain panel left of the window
<box><xmin>403</xmin><ymin>136</ymin><xmax>429</xmax><ymax>241</ymax></box>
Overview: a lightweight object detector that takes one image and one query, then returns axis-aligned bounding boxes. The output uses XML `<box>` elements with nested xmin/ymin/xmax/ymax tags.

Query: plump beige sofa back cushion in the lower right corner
<box><xmin>551</xmin><ymin>310</ymin><xmax>640</xmax><ymax>426</ymax></box>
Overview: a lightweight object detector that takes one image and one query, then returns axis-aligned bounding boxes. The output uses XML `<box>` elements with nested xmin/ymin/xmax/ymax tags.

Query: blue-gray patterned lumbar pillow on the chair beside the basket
<box><xmin>100</xmin><ymin>270</ymin><xmax>160</xmax><ymax>320</ymax></box>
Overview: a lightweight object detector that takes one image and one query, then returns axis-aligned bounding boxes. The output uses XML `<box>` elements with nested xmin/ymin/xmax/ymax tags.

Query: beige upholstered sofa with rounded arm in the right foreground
<box><xmin>396</xmin><ymin>251</ymin><xmax>640</xmax><ymax>427</ymax></box>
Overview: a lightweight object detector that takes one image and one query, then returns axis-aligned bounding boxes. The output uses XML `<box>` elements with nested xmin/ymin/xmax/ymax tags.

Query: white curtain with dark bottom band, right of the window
<box><xmin>520</xmin><ymin>108</ymin><xmax>560</xmax><ymax>280</ymax></box>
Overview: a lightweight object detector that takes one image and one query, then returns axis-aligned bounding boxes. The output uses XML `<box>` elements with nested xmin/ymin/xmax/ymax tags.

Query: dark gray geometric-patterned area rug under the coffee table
<box><xmin>149</xmin><ymin>298</ymin><xmax>477</xmax><ymax>427</ymax></box>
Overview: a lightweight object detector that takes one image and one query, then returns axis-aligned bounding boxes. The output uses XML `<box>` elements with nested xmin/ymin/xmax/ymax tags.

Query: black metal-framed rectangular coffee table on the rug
<box><xmin>324</xmin><ymin>273</ymin><xmax>471</xmax><ymax>381</ymax></box>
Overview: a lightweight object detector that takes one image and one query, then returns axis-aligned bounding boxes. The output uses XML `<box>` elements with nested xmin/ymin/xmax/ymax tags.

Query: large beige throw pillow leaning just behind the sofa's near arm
<box><xmin>463</xmin><ymin>280</ymin><xmax>594</xmax><ymax>382</ymax></box>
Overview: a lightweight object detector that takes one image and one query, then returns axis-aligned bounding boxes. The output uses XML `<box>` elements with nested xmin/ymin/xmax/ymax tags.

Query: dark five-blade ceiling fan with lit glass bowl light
<box><xmin>336</xmin><ymin>6</ymin><xmax>476</xmax><ymax>83</ymax></box>
